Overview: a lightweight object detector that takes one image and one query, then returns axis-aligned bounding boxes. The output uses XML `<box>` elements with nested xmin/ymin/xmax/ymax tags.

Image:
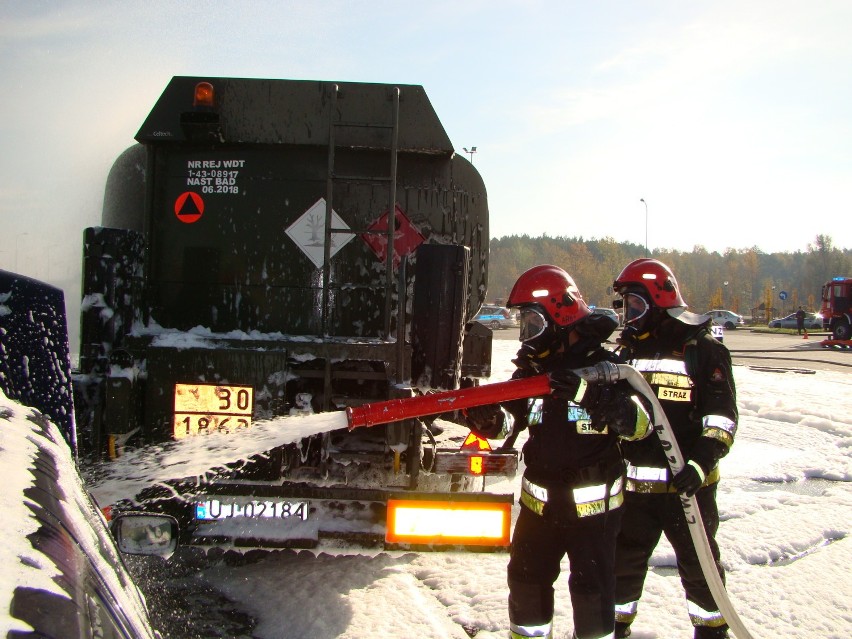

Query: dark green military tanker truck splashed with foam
<box><xmin>74</xmin><ymin>77</ymin><xmax>518</xmax><ymax>548</ymax></box>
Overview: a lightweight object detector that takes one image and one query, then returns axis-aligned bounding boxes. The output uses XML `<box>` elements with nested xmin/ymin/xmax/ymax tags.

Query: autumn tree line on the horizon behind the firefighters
<box><xmin>488</xmin><ymin>235</ymin><xmax>852</xmax><ymax>322</ymax></box>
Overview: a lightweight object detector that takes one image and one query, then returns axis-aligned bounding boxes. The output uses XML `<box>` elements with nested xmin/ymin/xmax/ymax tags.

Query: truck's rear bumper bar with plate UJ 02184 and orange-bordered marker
<box><xmin>173</xmin><ymin>483</ymin><xmax>514</xmax><ymax>551</ymax></box>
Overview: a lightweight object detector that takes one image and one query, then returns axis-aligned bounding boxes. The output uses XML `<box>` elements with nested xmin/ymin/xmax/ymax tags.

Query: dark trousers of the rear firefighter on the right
<box><xmin>615</xmin><ymin>484</ymin><xmax>725</xmax><ymax>628</ymax></box>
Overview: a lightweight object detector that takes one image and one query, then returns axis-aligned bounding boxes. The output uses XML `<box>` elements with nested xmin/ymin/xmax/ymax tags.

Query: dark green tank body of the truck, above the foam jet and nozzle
<box><xmin>75</xmin><ymin>77</ymin><xmax>490</xmax><ymax>462</ymax></box>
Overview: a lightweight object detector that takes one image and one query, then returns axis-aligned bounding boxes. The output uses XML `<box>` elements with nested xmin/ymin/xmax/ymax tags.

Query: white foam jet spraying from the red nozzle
<box><xmin>85</xmin><ymin>411</ymin><xmax>349</xmax><ymax>507</ymax></box>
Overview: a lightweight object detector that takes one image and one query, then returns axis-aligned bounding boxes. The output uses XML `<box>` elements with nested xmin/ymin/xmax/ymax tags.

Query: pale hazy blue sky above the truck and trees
<box><xmin>0</xmin><ymin>0</ymin><xmax>852</xmax><ymax>290</ymax></box>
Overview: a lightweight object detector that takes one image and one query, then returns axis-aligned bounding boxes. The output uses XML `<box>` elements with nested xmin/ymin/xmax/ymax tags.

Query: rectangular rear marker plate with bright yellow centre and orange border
<box><xmin>385</xmin><ymin>499</ymin><xmax>512</xmax><ymax>546</ymax></box>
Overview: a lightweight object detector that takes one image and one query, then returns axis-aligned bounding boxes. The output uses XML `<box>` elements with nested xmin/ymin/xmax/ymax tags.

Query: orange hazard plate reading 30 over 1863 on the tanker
<box><xmin>172</xmin><ymin>384</ymin><xmax>254</xmax><ymax>439</ymax></box>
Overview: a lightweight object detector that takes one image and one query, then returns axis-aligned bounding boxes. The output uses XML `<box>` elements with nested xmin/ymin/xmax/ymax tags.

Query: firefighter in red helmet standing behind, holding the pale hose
<box><xmin>613</xmin><ymin>258</ymin><xmax>737</xmax><ymax>639</ymax></box>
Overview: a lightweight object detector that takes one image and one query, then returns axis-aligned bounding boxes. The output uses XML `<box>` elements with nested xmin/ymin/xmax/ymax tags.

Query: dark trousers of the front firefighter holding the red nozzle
<box><xmin>508</xmin><ymin>505</ymin><xmax>623</xmax><ymax>639</ymax></box>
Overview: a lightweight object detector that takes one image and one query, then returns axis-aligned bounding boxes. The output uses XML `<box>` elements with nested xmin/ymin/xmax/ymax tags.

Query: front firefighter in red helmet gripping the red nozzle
<box><xmin>467</xmin><ymin>265</ymin><xmax>649</xmax><ymax>639</ymax></box>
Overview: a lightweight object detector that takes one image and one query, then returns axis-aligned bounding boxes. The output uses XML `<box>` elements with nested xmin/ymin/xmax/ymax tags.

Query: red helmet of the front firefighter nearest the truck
<box><xmin>506</xmin><ymin>264</ymin><xmax>592</xmax><ymax>327</ymax></box>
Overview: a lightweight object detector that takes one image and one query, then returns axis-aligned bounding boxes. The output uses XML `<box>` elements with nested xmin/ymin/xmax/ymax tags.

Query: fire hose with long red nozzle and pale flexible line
<box><xmin>346</xmin><ymin>362</ymin><xmax>753</xmax><ymax>639</ymax></box>
